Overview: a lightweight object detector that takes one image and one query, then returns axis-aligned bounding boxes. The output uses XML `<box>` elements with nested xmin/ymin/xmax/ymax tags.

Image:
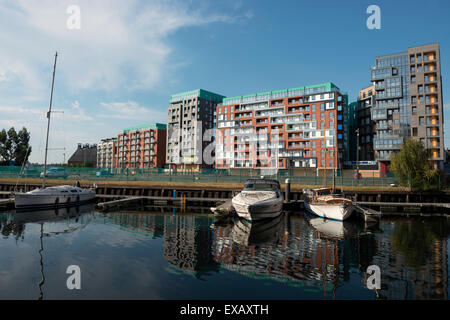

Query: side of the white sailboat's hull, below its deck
<box><xmin>14</xmin><ymin>192</ymin><xmax>95</xmax><ymax>209</ymax></box>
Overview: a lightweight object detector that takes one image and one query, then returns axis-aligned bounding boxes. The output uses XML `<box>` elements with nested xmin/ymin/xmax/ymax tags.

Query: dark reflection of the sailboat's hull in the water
<box><xmin>14</xmin><ymin>204</ymin><xmax>94</xmax><ymax>224</ymax></box>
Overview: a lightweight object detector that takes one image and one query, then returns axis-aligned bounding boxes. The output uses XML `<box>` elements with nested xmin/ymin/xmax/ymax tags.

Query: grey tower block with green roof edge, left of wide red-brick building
<box><xmin>166</xmin><ymin>89</ymin><xmax>224</xmax><ymax>170</ymax></box>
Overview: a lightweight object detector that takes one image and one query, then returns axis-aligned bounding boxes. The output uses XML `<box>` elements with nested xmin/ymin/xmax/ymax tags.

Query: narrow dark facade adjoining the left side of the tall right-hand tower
<box><xmin>355</xmin><ymin>86</ymin><xmax>375</xmax><ymax>161</ymax></box>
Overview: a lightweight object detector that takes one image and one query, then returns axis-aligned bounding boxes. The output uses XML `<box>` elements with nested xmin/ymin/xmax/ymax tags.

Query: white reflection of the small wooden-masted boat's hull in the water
<box><xmin>305</xmin><ymin>214</ymin><xmax>357</xmax><ymax>239</ymax></box>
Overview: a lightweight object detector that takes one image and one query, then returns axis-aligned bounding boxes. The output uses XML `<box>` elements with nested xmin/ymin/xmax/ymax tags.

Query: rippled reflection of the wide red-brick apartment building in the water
<box><xmin>214</xmin><ymin>217</ymin><xmax>343</xmax><ymax>291</ymax></box>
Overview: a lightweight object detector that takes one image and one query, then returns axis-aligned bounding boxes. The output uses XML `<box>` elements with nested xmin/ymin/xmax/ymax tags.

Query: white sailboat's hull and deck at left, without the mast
<box><xmin>15</xmin><ymin>186</ymin><xmax>95</xmax><ymax>209</ymax></box>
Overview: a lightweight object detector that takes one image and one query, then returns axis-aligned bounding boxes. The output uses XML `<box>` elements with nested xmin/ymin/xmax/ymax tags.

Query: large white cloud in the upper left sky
<box><xmin>0</xmin><ymin>0</ymin><xmax>239</xmax><ymax>91</ymax></box>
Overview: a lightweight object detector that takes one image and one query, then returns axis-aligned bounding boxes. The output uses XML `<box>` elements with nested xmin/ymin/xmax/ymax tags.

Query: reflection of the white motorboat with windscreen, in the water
<box><xmin>231</xmin><ymin>214</ymin><xmax>284</xmax><ymax>246</ymax></box>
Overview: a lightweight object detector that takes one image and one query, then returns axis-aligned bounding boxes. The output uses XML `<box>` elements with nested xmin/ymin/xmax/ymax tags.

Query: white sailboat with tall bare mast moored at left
<box><xmin>14</xmin><ymin>52</ymin><xmax>95</xmax><ymax>209</ymax></box>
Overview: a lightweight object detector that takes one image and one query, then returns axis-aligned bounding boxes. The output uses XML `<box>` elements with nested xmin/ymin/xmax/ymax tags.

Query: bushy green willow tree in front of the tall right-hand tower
<box><xmin>391</xmin><ymin>139</ymin><xmax>440</xmax><ymax>190</ymax></box>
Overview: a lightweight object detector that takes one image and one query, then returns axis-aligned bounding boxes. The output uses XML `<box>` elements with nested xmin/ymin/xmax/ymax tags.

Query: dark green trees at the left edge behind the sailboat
<box><xmin>0</xmin><ymin>127</ymin><xmax>31</xmax><ymax>166</ymax></box>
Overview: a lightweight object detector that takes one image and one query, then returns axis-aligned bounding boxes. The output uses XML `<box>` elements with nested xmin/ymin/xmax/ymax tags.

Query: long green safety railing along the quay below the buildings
<box><xmin>0</xmin><ymin>166</ymin><xmax>398</xmax><ymax>187</ymax></box>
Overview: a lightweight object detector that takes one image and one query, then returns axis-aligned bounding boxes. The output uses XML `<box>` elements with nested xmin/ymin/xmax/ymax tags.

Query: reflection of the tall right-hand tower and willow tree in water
<box><xmin>372</xmin><ymin>219</ymin><xmax>448</xmax><ymax>300</ymax></box>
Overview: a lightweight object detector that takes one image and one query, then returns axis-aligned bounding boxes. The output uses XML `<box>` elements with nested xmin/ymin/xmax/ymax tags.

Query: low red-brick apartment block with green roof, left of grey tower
<box><xmin>114</xmin><ymin>123</ymin><xmax>166</xmax><ymax>169</ymax></box>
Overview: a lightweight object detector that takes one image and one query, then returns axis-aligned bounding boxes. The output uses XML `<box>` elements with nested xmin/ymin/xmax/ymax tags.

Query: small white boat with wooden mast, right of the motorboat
<box><xmin>303</xmin><ymin>188</ymin><xmax>354</xmax><ymax>221</ymax></box>
